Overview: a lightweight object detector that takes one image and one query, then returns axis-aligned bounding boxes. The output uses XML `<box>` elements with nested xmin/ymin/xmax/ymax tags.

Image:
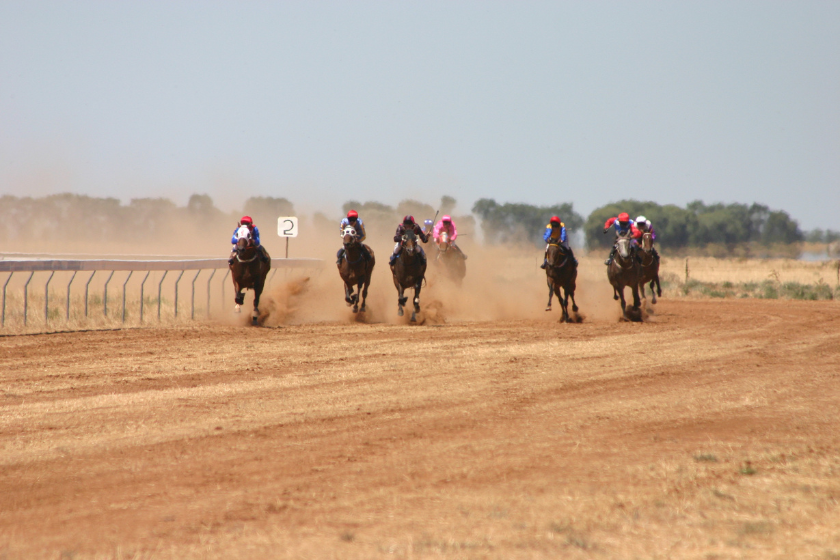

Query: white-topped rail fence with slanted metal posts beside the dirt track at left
<box><xmin>0</xmin><ymin>259</ymin><xmax>323</xmax><ymax>328</ymax></box>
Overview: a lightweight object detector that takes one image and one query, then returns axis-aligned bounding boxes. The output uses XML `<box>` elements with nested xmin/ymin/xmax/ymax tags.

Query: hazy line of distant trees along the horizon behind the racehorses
<box><xmin>0</xmin><ymin>193</ymin><xmax>840</xmax><ymax>253</ymax></box>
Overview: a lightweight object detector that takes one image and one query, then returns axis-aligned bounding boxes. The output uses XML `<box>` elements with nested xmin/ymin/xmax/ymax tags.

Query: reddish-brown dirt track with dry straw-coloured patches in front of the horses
<box><xmin>0</xmin><ymin>300</ymin><xmax>840</xmax><ymax>559</ymax></box>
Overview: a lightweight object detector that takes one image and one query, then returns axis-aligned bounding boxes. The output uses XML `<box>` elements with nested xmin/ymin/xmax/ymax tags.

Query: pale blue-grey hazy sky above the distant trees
<box><xmin>0</xmin><ymin>0</ymin><xmax>840</xmax><ymax>229</ymax></box>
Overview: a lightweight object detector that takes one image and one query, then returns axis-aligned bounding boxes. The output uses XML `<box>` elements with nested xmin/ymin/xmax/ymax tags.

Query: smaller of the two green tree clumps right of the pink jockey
<box><xmin>472</xmin><ymin>198</ymin><xmax>583</xmax><ymax>245</ymax></box>
